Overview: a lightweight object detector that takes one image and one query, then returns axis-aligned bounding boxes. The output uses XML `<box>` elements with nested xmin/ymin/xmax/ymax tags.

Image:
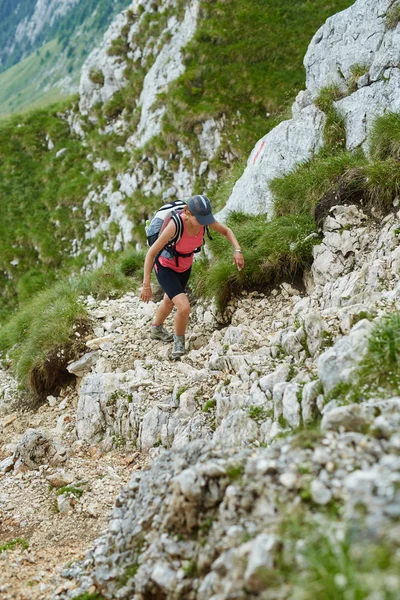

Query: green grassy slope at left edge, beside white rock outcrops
<box><xmin>0</xmin><ymin>102</ymin><xmax>93</xmax><ymax>321</ymax></box>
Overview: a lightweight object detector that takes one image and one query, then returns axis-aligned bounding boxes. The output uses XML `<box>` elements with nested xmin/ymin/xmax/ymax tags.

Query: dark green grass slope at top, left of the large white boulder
<box><xmin>165</xmin><ymin>0</ymin><xmax>352</xmax><ymax>161</ymax></box>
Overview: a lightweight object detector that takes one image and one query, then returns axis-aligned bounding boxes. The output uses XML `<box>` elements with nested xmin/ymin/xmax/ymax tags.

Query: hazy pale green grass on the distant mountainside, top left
<box><xmin>0</xmin><ymin>0</ymin><xmax>127</xmax><ymax>115</ymax></box>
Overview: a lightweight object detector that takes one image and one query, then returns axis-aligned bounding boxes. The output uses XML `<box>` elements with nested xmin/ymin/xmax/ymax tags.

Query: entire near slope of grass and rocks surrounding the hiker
<box><xmin>0</xmin><ymin>0</ymin><xmax>400</xmax><ymax>600</ymax></box>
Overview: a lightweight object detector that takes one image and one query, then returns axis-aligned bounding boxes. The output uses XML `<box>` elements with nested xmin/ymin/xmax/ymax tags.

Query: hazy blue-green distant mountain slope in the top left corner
<box><xmin>0</xmin><ymin>0</ymin><xmax>129</xmax><ymax>115</ymax></box>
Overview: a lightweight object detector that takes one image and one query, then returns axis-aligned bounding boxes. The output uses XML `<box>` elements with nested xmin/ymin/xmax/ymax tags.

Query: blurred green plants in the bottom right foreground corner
<box><xmin>259</xmin><ymin>510</ymin><xmax>400</xmax><ymax>600</ymax></box>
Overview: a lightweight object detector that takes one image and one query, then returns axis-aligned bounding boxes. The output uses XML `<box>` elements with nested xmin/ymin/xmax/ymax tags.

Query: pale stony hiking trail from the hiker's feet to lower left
<box><xmin>0</xmin><ymin>286</ymin><xmax>300</xmax><ymax>600</ymax></box>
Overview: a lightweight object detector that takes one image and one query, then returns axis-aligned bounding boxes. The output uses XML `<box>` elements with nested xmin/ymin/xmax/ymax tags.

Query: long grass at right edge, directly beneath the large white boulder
<box><xmin>270</xmin><ymin>113</ymin><xmax>400</xmax><ymax>220</ymax></box>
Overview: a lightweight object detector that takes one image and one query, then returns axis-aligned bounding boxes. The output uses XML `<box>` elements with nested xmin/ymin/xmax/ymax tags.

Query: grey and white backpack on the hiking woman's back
<box><xmin>145</xmin><ymin>200</ymin><xmax>212</xmax><ymax>266</ymax></box>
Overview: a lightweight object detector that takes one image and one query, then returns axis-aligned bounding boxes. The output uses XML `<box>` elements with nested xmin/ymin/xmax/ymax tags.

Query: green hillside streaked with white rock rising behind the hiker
<box><xmin>0</xmin><ymin>0</ymin><xmax>349</xmax><ymax>321</ymax></box>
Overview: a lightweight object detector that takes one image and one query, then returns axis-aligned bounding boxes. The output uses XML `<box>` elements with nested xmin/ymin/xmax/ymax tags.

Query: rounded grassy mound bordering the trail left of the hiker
<box><xmin>0</xmin><ymin>251</ymin><xmax>143</xmax><ymax>399</ymax></box>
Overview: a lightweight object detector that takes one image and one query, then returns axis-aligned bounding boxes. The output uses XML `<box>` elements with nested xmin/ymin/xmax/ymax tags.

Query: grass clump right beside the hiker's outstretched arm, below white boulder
<box><xmin>193</xmin><ymin>214</ymin><xmax>317</xmax><ymax>309</ymax></box>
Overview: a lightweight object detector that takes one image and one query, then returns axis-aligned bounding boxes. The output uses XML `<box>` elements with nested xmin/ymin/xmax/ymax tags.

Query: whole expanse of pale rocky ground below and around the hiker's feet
<box><xmin>0</xmin><ymin>206</ymin><xmax>400</xmax><ymax>600</ymax></box>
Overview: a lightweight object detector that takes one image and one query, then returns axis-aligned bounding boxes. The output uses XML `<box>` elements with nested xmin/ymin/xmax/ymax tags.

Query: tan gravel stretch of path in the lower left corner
<box><xmin>0</xmin><ymin>384</ymin><xmax>148</xmax><ymax>600</ymax></box>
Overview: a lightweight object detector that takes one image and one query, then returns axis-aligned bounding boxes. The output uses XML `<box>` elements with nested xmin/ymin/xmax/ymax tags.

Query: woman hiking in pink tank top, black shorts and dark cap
<box><xmin>140</xmin><ymin>196</ymin><xmax>244</xmax><ymax>360</ymax></box>
